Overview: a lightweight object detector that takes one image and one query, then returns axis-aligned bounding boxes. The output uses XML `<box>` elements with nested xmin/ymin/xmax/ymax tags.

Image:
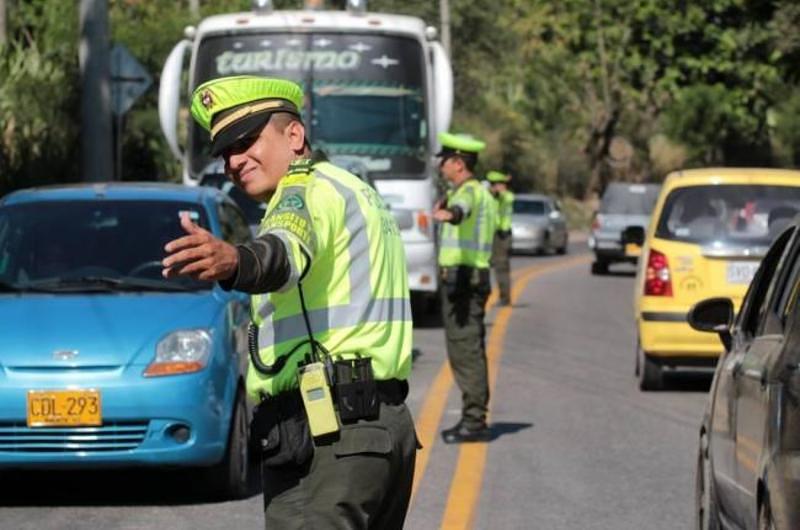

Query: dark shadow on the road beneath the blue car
<box><xmin>0</xmin><ymin>470</ymin><xmax>261</xmax><ymax>507</ymax></box>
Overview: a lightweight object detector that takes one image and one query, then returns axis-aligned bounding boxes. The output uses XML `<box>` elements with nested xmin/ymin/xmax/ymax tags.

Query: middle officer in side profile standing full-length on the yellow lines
<box><xmin>433</xmin><ymin>133</ymin><xmax>497</xmax><ymax>443</ymax></box>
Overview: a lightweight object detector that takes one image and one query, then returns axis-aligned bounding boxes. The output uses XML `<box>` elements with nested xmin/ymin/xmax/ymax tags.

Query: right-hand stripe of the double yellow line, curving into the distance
<box><xmin>441</xmin><ymin>255</ymin><xmax>589</xmax><ymax>530</ymax></box>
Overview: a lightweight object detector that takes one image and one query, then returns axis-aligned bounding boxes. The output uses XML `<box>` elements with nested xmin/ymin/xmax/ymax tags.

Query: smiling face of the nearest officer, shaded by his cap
<box><xmin>222</xmin><ymin>117</ymin><xmax>305</xmax><ymax>201</ymax></box>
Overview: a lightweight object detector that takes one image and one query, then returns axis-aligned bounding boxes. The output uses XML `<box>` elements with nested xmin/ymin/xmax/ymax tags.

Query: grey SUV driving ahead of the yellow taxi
<box><xmin>589</xmin><ymin>182</ymin><xmax>661</xmax><ymax>274</ymax></box>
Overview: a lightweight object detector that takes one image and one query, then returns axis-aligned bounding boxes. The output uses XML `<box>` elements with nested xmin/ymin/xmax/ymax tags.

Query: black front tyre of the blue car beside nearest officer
<box><xmin>206</xmin><ymin>390</ymin><xmax>254</xmax><ymax>499</ymax></box>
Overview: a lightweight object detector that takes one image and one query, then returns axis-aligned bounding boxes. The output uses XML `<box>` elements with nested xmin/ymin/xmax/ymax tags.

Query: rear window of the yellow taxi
<box><xmin>656</xmin><ymin>185</ymin><xmax>800</xmax><ymax>246</ymax></box>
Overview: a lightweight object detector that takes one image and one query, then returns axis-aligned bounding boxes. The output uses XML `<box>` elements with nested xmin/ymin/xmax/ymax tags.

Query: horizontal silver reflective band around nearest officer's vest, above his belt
<box><xmin>258</xmin><ymin>298</ymin><xmax>411</xmax><ymax>348</ymax></box>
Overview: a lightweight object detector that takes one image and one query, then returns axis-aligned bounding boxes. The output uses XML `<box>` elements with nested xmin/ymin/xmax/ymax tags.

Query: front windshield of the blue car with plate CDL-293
<box><xmin>0</xmin><ymin>199</ymin><xmax>211</xmax><ymax>292</ymax></box>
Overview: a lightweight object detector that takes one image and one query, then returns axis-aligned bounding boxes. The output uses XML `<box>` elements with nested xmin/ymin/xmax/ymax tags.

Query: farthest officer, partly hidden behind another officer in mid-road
<box><xmin>486</xmin><ymin>171</ymin><xmax>514</xmax><ymax>305</ymax></box>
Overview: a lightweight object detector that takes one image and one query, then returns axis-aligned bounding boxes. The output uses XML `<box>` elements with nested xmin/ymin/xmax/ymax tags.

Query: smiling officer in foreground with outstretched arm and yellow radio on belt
<box><xmin>163</xmin><ymin>76</ymin><xmax>416</xmax><ymax>530</ymax></box>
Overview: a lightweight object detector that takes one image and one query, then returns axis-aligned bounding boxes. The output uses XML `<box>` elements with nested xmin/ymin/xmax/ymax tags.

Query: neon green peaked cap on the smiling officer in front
<box><xmin>192</xmin><ymin>75</ymin><xmax>303</xmax><ymax>156</ymax></box>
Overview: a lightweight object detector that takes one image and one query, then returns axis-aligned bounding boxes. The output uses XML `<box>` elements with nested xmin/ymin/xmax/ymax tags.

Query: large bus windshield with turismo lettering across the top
<box><xmin>190</xmin><ymin>33</ymin><xmax>429</xmax><ymax>179</ymax></box>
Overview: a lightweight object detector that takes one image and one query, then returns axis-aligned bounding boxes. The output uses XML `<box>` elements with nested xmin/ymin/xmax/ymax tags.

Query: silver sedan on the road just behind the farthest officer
<box><xmin>511</xmin><ymin>193</ymin><xmax>569</xmax><ymax>254</ymax></box>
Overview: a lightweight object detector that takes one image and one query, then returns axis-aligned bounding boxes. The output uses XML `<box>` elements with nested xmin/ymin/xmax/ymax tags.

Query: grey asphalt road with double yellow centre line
<box><xmin>0</xmin><ymin>240</ymin><xmax>709</xmax><ymax>530</ymax></box>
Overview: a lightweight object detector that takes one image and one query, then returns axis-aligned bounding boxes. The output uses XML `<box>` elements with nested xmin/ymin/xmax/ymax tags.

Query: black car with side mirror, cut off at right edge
<box><xmin>689</xmin><ymin>220</ymin><xmax>800</xmax><ymax>529</ymax></box>
